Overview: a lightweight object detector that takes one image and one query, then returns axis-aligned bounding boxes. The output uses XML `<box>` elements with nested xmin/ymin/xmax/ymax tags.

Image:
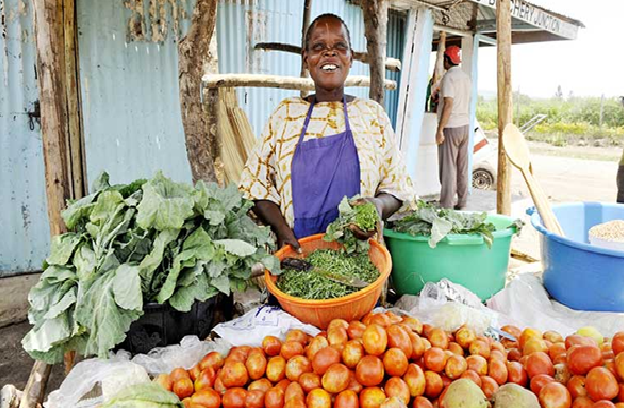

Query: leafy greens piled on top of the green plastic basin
<box><xmin>392</xmin><ymin>201</ymin><xmax>496</xmax><ymax>248</ymax></box>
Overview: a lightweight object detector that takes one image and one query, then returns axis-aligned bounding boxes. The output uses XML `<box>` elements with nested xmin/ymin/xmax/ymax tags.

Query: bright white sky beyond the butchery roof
<box><xmin>478</xmin><ymin>0</ymin><xmax>624</xmax><ymax>97</ymax></box>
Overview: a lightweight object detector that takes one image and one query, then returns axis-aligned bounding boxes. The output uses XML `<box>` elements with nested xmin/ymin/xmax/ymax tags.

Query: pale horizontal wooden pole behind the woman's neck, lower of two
<box><xmin>202</xmin><ymin>74</ymin><xmax>397</xmax><ymax>91</ymax></box>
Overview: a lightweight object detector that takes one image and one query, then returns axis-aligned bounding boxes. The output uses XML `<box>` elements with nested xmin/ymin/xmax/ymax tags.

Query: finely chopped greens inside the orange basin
<box><xmin>277</xmin><ymin>249</ymin><xmax>379</xmax><ymax>299</ymax></box>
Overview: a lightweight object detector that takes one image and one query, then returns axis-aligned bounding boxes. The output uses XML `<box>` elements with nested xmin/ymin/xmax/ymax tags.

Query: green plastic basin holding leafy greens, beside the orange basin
<box><xmin>384</xmin><ymin>215</ymin><xmax>516</xmax><ymax>300</ymax></box>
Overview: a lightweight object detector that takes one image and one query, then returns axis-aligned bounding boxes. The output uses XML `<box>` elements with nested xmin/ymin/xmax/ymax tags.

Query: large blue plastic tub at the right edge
<box><xmin>527</xmin><ymin>202</ymin><xmax>624</xmax><ymax>312</ymax></box>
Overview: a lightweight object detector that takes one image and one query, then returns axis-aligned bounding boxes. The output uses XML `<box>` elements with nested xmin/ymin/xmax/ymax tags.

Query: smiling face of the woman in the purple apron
<box><xmin>303</xmin><ymin>18</ymin><xmax>353</xmax><ymax>91</ymax></box>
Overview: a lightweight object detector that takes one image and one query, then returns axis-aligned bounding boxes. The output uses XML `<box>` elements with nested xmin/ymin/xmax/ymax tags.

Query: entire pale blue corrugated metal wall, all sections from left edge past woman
<box><xmin>0</xmin><ymin>0</ymin><xmax>405</xmax><ymax>276</ymax></box>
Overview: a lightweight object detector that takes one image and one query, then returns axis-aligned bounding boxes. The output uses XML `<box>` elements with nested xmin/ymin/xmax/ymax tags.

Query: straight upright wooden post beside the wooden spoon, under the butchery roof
<box><xmin>496</xmin><ymin>0</ymin><xmax>513</xmax><ymax>215</ymax></box>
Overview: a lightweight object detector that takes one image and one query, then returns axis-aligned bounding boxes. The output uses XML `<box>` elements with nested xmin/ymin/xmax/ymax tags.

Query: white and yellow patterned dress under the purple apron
<box><xmin>239</xmin><ymin>97</ymin><xmax>416</xmax><ymax>227</ymax></box>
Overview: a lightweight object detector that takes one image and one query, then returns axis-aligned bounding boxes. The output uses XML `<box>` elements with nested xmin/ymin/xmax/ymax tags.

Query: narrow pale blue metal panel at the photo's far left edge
<box><xmin>0</xmin><ymin>0</ymin><xmax>50</xmax><ymax>276</ymax></box>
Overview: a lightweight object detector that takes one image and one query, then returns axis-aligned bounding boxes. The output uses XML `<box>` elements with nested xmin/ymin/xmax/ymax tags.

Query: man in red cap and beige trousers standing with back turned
<box><xmin>436</xmin><ymin>46</ymin><xmax>471</xmax><ymax>210</ymax></box>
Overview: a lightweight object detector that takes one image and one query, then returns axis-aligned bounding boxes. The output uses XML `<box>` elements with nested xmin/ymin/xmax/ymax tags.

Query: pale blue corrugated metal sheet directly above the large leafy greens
<box><xmin>77</xmin><ymin>0</ymin><xmax>193</xmax><ymax>183</ymax></box>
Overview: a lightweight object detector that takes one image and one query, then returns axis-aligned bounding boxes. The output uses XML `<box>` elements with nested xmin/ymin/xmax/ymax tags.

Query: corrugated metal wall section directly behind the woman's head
<box><xmin>217</xmin><ymin>0</ymin><xmax>405</xmax><ymax>136</ymax></box>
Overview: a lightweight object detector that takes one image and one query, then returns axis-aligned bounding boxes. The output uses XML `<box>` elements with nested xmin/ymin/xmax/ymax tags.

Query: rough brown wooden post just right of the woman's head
<box><xmin>362</xmin><ymin>0</ymin><xmax>388</xmax><ymax>106</ymax></box>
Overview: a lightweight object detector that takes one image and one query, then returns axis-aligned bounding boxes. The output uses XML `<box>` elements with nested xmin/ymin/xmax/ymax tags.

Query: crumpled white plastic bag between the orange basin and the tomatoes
<box><xmin>213</xmin><ymin>306</ymin><xmax>319</xmax><ymax>347</ymax></box>
